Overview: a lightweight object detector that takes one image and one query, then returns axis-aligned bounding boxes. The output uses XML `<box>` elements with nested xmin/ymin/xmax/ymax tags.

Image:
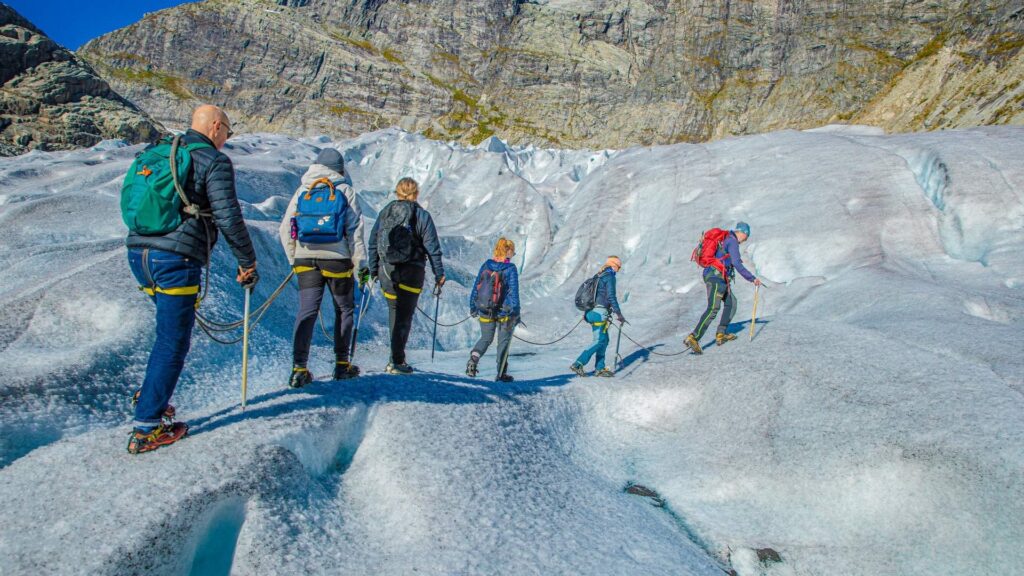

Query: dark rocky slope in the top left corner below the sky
<box><xmin>0</xmin><ymin>3</ymin><xmax>160</xmax><ymax>156</ymax></box>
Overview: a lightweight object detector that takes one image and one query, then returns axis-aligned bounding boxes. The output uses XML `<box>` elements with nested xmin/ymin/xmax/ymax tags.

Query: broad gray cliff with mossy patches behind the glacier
<box><xmin>81</xmin><ymin>0</ymin><xmax>1024</xmax><ymax>148</ymax></box>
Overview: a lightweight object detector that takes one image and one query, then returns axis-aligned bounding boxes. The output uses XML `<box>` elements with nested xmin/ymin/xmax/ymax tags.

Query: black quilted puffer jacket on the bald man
<box><xmin>125</xmin><ymin>129</ymin><xmax>256</xmax><ymax>268</ymax></box>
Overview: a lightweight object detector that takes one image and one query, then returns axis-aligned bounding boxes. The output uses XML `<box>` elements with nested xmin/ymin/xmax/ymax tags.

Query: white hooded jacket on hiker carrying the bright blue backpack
<box><xmin>278</xmin><ymin>164</ymin><xmax>367</xmax><ymax>270</ymax></box>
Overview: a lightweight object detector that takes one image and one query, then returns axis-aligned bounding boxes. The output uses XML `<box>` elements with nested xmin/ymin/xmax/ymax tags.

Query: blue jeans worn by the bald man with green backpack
<box><xmin>128</xmin><ymin>248</ymin><xmax>203</xmax><ymax>429</ymax></box>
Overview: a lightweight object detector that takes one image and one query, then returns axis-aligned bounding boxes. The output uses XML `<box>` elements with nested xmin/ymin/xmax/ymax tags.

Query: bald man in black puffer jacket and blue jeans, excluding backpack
<box><xmin>125</xmin><ymin>105</ymin><xmax>259</xmax><ymax>454</ymax></box>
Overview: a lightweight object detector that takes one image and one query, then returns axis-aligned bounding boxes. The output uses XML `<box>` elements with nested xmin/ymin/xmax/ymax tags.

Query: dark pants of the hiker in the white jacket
<box><xmin>292</xmin><ymin>258</ymin><xmax>355</xmax><ymax>366</ymax></box>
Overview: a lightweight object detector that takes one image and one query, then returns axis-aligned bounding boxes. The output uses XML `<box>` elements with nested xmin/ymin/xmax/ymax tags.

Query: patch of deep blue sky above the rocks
<box><xmin>3</xmin><ymin>0</ymin><xmax>189</xmax><ymax>50</ymax></box>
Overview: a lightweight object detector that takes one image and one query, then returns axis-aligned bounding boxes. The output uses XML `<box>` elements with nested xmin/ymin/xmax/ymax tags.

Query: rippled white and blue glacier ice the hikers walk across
<box><xmin>0</xmin><ymin>127</ymin><xmax>1024</xmax><ymax>576</ymax></box>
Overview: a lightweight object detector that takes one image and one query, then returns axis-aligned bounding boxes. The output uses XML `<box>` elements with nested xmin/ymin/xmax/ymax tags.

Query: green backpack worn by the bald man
<box><xmin>121</xmin><ymin>136</ymin><xmax>213</xmax><ymax>236</ymax></box>
